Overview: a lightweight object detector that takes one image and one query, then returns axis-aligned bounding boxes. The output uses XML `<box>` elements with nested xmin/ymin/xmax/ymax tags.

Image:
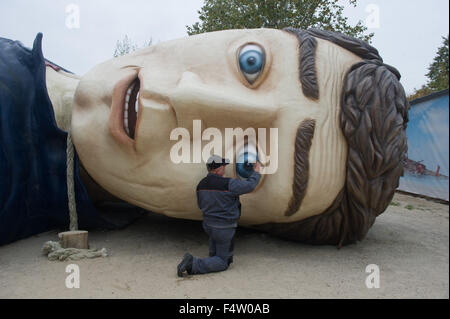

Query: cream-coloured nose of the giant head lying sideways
<box><xmin>170</xmin><ymin>71</ymin><xmax>278</xmax><ymax>131</ymax></box>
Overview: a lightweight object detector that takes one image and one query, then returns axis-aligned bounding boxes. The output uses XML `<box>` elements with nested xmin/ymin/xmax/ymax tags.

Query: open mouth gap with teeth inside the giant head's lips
<box><xmin>123</xmin><ymin>78</ymin><xmax>141</xmax><ymax>139</ymax></box>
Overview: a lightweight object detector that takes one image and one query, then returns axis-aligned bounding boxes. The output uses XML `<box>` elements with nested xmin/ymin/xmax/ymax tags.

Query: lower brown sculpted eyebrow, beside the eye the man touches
<box><xmin>284</xmin><ymin>119</ymin><xmax>316</xmax><ymax>216</ymax></box>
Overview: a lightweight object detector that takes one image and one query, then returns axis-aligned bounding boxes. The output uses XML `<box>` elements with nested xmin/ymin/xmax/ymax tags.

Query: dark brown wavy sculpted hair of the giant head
<box><xmin>258</xmin><ymin>29</ymin><xmax>409</xmax><ymax>247</ymax></box>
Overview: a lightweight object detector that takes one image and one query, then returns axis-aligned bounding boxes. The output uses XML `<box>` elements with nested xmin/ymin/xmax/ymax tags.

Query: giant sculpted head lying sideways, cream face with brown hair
<box><xmin>72</xmin><ymin>29</ymin><xmax>407</xmax><ymax>248</ymax></box>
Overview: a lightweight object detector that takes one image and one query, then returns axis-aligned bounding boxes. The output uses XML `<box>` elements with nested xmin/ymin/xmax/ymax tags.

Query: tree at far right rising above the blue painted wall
<box><xmin>408</xmin><ymin>35</ymin><xmax>449</xmax><ymax>101</ymax></box>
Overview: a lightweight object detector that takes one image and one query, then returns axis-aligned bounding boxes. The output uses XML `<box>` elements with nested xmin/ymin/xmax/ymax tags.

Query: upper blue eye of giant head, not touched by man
<box><xmin>239</xmin><ymin>44</ymin><xmax>265</xmax><ymax>84</ymax></box>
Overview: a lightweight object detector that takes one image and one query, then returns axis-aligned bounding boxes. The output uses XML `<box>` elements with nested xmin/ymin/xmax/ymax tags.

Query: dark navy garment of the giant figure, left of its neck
<box><xmin>0</xmin><ymin>33</ymin><xmax>108</xmax><ymax>245</ymax></box>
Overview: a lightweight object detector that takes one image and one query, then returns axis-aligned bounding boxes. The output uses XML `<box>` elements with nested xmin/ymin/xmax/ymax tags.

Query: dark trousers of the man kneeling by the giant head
<box><xmin>192</xmin><ymin>222</ymin><xmax>236</xmax><ymax>274</ymax></box>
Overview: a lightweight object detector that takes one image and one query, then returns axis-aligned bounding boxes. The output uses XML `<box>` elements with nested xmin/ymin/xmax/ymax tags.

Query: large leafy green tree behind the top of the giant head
<box><xmin>186</xmin><ymin>0</ymin><xmax>373</xmax><ymax>42</ymax></box>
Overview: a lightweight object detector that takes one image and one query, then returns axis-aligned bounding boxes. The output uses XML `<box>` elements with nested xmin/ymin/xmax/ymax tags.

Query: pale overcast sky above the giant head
<box><xmin>0</xmin><ymin>0</ymin><xmax>449</xmax><ymax>94</ymax></box>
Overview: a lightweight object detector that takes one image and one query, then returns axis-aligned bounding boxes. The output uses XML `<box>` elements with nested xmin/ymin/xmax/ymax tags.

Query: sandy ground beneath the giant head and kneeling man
<box><xmin>0</xmin><ymin>194</ymin><xmax>449</xmax><ymax>299</ymax></box>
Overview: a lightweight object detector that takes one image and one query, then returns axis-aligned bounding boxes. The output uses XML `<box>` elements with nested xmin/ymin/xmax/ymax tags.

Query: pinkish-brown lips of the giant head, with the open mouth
<box><xmin>109</xmin><ymin>73</ymin><xmax>141</xmax><ymax>145</ymax></box>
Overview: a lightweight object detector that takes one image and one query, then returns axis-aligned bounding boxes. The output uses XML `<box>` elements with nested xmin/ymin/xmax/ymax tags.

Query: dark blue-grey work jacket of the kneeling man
<box><xmin>197</xmin><ymin>172</ymin><xmax>261</xmax><ymax>228</ymax></box>
